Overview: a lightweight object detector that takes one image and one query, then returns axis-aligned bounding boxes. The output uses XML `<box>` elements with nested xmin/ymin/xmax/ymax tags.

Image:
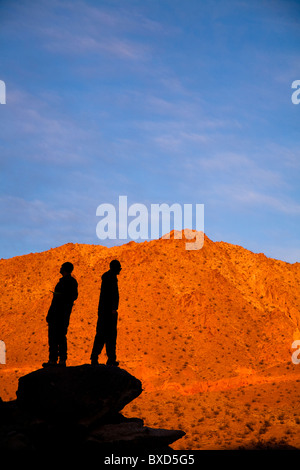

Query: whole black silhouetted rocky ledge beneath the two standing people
<box><xmin>0</xmin><ymin>364</ymin><xmax>185</xmax><ymax>453</ymax></box>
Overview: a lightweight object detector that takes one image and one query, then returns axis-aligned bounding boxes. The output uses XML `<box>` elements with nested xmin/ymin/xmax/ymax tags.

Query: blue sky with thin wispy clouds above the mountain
<box><xmin>0</xmin><ymin>0</ymin><xmax>300</xmax><ymax>263</ymax></box>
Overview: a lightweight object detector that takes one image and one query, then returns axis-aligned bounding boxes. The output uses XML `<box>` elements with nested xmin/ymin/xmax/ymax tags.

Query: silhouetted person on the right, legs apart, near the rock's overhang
<box><xmin>91</xmin><ymin>260</ymin><xmax>122</xmax><ymax>366</ymax></box>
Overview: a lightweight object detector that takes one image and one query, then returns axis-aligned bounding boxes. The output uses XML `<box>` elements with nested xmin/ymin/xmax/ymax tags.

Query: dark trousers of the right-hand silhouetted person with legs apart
<box><xmin>91</xmin><ymin>312</ymin><xmax>118</xmax><ymax>362</ymax></box>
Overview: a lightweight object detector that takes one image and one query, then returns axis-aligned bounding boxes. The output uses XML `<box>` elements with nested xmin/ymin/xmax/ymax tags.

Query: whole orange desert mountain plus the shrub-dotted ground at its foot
<box><xmin>0</xmin><ymin>240</ymin><xmax>300</xmax><ymax>449</ymax></box>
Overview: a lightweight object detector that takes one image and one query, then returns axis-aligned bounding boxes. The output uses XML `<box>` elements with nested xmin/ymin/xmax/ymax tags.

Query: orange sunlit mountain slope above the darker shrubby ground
<box><xmin>0</xmin><ymin>234</ymin><xmax>300</xmax><ymax>450</ymax></box>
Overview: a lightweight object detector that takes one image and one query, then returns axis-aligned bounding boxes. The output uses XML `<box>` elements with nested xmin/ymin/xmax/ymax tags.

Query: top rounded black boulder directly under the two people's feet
<box><xmin>17</xmin><ymin>364</ymin><xmax>142</xmax><ymax>423</ymax></box>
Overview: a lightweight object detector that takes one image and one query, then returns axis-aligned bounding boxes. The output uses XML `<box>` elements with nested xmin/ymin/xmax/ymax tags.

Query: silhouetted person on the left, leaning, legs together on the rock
<box><xmin>43</xmin><ymin>262</ymin><xmax>78</xmax><ymax>367</ymax></box>
